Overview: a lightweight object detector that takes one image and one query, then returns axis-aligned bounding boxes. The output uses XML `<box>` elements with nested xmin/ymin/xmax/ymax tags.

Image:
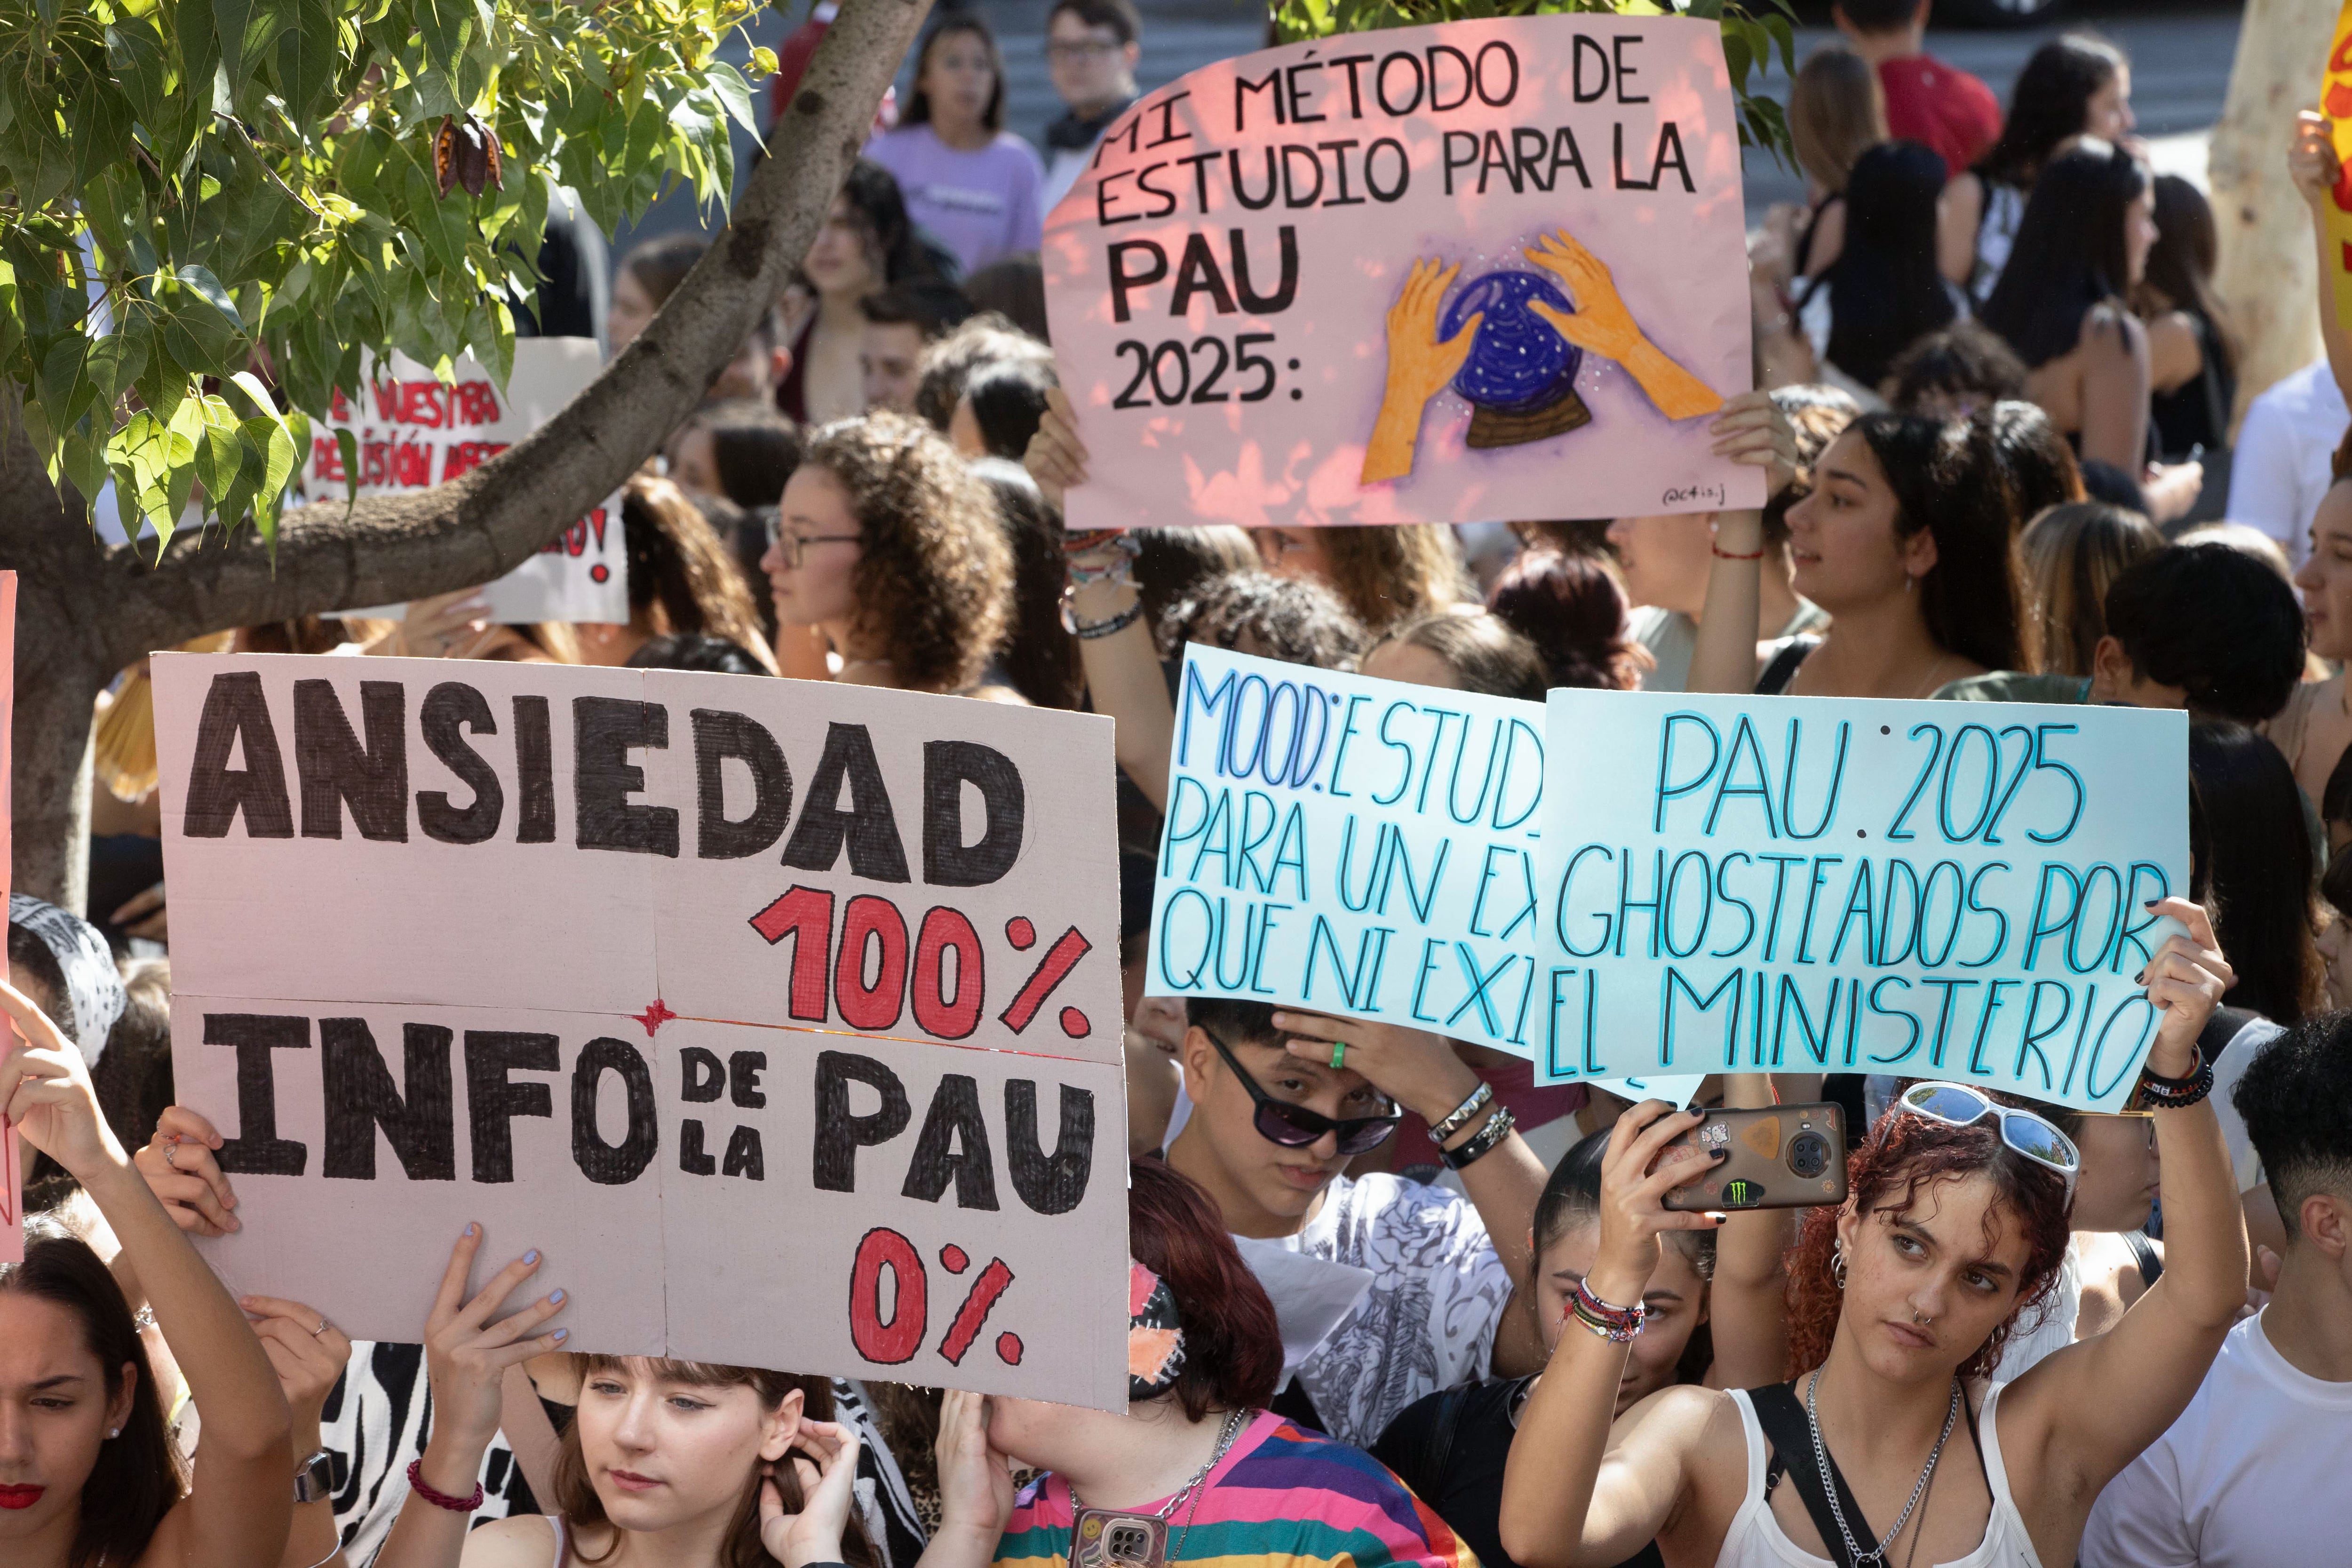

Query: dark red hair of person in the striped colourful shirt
<box><xmin>1127</xmin><ymin>1159</ymin><xmax>1282</xmax><ymax>1420</ymax></box>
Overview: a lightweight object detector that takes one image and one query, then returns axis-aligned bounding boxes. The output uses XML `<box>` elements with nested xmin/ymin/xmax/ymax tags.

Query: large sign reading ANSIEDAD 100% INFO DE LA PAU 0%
<box><xmin>155</xmin><ymin>656</ymin><xmax>1127</xmax><ymax>1408</ymax></box>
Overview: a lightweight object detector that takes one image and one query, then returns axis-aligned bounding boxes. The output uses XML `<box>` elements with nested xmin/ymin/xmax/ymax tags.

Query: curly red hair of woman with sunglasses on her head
<box><xmin>1788</xmin><ymin>1110</ymin><xmax>2067</xmax><ymax>1377</ymax></box>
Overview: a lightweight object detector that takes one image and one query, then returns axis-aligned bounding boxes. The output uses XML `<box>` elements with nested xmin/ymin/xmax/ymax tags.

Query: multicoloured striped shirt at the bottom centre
<box><xmin>995</xmin><ymin>1410</ymin><xmax>1477</xmax><ymax>1568</ymax></box>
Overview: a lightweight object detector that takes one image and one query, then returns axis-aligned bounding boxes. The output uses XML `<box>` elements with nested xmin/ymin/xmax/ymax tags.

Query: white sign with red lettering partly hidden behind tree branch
<box><xmin>303</xmin><ymin>339</ymin><xmax>628</xmax><ymax>623</ymax></box>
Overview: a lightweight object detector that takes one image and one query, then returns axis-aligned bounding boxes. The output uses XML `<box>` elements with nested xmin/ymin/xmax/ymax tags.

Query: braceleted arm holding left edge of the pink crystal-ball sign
<box><xmin>1021</xmin><ymin>388</ymin><xmax>1176</xmax><ymax>811</ymax></box>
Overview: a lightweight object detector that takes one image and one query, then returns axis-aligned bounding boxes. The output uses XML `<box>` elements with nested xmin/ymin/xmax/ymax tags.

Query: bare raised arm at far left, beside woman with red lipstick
<box><xmin>0</xmin><ymin>983</ymin><xmax>294</xmax><ymax>1568</ymax></box>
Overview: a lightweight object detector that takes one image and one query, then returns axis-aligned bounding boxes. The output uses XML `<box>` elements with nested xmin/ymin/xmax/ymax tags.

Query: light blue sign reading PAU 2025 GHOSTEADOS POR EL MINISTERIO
<box><xmin>1529</xmin><ymin>691</ymin><xmax>2190</xmax><ymax>1110</ymax></box>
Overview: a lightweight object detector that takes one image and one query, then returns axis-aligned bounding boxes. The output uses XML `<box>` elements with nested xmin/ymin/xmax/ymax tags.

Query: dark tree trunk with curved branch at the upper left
<box><xmin>0</xmin><ymin>0</ymin><xmax>929</xmax><ymax>910</ymax></box>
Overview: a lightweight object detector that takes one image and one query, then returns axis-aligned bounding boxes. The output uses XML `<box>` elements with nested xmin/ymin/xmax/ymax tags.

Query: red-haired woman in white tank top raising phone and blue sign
<box><xmin>1501</xmin><ymin>898</ymin><xmax>2246</xmax><ymax>1568</ymax></box>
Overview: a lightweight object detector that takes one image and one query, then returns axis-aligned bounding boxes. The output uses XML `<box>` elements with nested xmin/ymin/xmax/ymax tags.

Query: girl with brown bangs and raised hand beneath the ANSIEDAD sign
<box><xmin>376</xmin><ymin>1225</ymin><xmax>875</xmax><ymax>1568</ymax></box>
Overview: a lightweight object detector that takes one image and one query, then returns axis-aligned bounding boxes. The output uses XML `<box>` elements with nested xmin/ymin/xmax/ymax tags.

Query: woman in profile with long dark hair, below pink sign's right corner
<box><xmin>1689</xmin><ymin>404</ymin><xmax>2034</xmax><ymax>698</ymax></box>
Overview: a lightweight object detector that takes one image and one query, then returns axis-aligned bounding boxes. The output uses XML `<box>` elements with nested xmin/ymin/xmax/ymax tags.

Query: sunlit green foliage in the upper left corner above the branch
<box><xmin>0</xmin><ymin>0</ymin><xmax>774</xmax><ymax>555</ymax></box>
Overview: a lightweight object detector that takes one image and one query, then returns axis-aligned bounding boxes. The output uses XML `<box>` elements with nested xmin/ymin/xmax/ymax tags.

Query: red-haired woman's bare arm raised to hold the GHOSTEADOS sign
<box><xmin>2002</xmin><ymin>898</ymin><xmax>2246</xmax><ymax>1523</ymax></box>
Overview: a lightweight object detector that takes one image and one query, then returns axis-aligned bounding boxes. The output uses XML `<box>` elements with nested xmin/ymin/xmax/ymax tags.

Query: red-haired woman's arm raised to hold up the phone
<box><xmin>1501</xmin><ymin>1100</ymin><xmax>1719</xmax><ymax>1568</ymax></box>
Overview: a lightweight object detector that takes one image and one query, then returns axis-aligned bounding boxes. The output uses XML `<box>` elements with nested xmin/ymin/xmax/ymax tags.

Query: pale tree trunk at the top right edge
<box><xmin>2206</xmin><ymin>0</ymin><xmax>2338</xmax><ymax>432</ymax></box>
